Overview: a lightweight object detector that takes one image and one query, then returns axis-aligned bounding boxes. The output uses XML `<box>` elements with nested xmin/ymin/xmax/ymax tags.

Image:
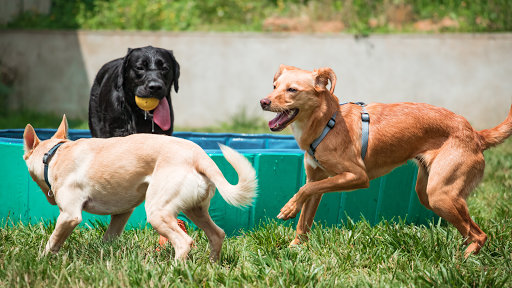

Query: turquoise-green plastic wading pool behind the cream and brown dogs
<box><xmin>0</xmin><ymin>129</ymin><xmax>439</xmax><ymax>235</ymax></box>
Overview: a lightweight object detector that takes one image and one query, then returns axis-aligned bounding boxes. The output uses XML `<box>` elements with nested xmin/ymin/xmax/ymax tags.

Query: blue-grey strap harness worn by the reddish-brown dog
<box><xmin>308</xmin><ymin>102</ymin><xmax>370</xmax><ymax>162</ymax></box>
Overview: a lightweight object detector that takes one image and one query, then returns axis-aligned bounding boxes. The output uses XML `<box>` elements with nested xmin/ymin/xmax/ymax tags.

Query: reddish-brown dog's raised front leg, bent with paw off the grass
<box><xmin>277</xmin><ymin>172</ymin><xmax>370</xmax><ymax>220</ymax></box>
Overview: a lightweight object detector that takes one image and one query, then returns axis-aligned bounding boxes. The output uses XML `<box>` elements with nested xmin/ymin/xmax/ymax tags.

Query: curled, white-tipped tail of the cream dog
<box><xmin>197</xmin><ymin>144</ymin><xmax>258</xmax><ymax>207</ymax></box>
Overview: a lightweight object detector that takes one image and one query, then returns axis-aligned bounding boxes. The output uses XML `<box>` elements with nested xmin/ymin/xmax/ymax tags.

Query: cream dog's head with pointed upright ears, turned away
<box><xmin>23</xmin><ymin>115</ymin><xmax>69</xmax><ymax>205</ymax></box>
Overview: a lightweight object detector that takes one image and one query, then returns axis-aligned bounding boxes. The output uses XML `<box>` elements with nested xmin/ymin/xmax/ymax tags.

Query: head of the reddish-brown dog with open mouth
<box><xmin>260</xmin><ymin>64</ymin><xmax>336</xmax><ymax>132</ymax></box>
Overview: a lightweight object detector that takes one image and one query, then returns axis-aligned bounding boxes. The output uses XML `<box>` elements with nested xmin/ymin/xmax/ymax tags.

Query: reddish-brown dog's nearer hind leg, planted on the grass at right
<box><xmin>427</xmin><ymin>149</ymin><xmax>487</xmax><ymax>257</ymax></box>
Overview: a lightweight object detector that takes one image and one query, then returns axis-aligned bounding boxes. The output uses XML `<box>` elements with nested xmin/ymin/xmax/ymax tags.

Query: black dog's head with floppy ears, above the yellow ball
<box><xmin>117</xmin><ymin>46</ymin><xmax>180</xmax><ymax>103</ymax></box>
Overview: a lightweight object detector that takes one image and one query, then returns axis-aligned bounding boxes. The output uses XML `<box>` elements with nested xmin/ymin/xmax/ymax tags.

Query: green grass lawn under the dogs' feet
<box><xmin>0</xmin><ymin>132</ymin><xmax>512</xmax><ymax>287</ymax></box>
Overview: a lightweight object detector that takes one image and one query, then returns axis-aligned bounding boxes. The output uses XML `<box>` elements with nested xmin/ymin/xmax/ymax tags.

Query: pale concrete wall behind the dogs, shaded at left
<box><xmin>0</xmin><ymin>31</ymin><xmax>512</xmax><ymax>129</ymax></box>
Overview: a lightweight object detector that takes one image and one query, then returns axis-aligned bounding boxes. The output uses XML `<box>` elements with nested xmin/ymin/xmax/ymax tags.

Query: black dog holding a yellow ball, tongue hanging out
<box><xmin>89</xmin><ymin>46</ymin><xmax>180</xmax><ymax>138</ymax></box>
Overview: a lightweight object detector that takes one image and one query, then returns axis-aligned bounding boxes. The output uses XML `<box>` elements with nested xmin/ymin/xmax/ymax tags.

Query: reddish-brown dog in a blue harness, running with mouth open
<box><xmin>260</xmin><ymin>65</ymin><xmax>512</xmax><ymax>257</ymax></box>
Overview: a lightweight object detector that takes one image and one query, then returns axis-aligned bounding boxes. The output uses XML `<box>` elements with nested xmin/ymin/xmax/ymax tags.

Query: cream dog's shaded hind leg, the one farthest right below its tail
<box><xmin>183</xmin><ymin>203</ymin><xmax>226</xmax><ymax>262</ymax></box>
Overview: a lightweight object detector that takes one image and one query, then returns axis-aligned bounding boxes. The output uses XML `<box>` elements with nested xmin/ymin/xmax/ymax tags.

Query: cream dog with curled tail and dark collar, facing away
<box><xmin>23</xmin><ymin>116</ymin><xmax>257</xmax><ymax>262</ymax></box>
